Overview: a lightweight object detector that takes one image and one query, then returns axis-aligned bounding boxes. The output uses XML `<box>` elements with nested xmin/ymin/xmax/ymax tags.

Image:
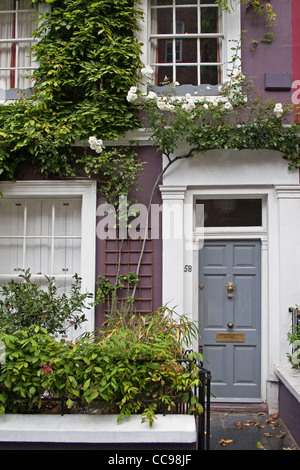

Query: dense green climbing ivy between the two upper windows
<box><xmin>0</xmin><ymin>0</ymin><xmax>142</xmax><ymax>179</ymax></box>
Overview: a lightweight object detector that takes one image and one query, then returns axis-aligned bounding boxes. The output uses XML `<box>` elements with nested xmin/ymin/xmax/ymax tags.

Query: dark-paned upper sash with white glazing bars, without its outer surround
<box><xmin>150</xmin><ymin>0</ymin><xmax>224</xmax><ymax>85</ymax></box>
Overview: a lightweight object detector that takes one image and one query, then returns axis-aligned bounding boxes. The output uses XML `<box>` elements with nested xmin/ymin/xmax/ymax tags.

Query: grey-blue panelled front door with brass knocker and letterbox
<box><xmin>199</xmin><ymin>240</ymin><xmax>261</xmax><ymax>401</ymax></box>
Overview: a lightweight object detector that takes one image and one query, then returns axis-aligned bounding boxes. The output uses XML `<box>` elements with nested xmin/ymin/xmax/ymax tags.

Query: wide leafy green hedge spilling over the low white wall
<box><xmin>0</xmin><ymin>309</ymin><xmax>202</xmax><ymax>424</ymax></box>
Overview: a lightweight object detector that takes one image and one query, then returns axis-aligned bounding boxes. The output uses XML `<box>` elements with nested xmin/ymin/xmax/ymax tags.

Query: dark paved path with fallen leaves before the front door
<box><xmin>210</xmin><ymin>408</ymin><xmax>299</xmax><ymax>451</ymax></box>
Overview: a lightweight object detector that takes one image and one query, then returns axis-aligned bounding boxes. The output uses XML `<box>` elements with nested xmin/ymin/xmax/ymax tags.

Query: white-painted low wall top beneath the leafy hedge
<box><xmin>0</xmin><ymin>414</ymin><xmax>197</xmax><ymax>446</ymax></box>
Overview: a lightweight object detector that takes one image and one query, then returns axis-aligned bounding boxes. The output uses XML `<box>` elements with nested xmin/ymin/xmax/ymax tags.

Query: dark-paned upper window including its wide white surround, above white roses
<box><xmin>139</xmin><ymin>0</ymin><xmax>241</xmax><ymax>94</ymax></box>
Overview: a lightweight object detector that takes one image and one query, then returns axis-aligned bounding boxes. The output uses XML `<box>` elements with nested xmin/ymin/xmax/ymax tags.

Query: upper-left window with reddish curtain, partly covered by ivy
<box><xmin>0</xmin><ymin>0</ymin><xmax>38</xmax><ymax>99</ymax></box>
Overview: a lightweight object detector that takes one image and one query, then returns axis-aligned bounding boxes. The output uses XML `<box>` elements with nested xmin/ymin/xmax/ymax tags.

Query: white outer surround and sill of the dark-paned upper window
<box><xmin>137</xmin><ymin>0</ymin><xmax>241</xmax><ymax>96</ymax></box>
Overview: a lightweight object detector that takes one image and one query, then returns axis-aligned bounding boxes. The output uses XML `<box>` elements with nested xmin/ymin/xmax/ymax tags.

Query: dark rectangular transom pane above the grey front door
<box><xmin>196</xmin><ymin>199</ymin><xmax>262</xmax><ymax>227</ymax></box>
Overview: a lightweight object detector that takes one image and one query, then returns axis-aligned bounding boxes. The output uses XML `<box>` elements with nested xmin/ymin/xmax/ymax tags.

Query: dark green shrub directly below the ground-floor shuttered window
<box><xmin>0</xmin><ymin>270</ymin><xmax>91</xmax><ymax>334</ymax></box>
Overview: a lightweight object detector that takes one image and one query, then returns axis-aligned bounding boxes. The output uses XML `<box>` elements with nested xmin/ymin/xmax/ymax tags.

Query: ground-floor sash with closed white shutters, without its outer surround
<box><xmin>0</xmin><ymin>198</ymin><xmax>81</xmax><ymax>288</ymax></box>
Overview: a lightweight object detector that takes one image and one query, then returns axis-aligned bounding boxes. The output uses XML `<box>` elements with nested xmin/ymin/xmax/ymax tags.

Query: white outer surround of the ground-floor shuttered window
<box><xmin>0</xmin><ymin>180</ymin><xmax>97</xmax><ymax>335</ymax></box>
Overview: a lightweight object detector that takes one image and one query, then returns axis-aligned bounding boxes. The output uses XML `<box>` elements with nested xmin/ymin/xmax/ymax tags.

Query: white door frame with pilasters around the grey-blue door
<box><xmin>160</xmin><ymin>185</ymin><xmax>280</xmax><ymax>402</ymax></box>
